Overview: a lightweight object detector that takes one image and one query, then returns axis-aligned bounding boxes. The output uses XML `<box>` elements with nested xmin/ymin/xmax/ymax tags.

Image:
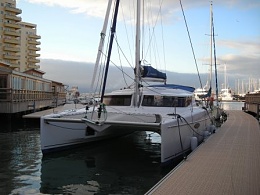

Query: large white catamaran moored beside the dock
<box><xmin>41</xmin><ymin>1</ymin><xmax>214</xmax><ymax>163</ymax></box>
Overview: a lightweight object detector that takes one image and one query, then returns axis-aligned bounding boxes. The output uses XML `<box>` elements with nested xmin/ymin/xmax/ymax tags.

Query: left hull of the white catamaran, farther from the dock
<box><xmin>41</xmin><ymin>111</ymin><xmax>133</xmax><ymax>153</ymax></box>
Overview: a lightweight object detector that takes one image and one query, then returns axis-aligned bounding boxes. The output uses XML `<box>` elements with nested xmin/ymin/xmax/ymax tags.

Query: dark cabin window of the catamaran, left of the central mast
<box><xmin>103</xmin><ymin>95</ymin><xmax>132</xmax><ymax>106</ymax></box>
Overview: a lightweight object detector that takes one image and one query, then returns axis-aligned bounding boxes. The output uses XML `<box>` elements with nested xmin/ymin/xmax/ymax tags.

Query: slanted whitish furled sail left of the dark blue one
<box><xmin>91</xmin><ymin>0</ymin><xmax>112</xmax><ymax>92</ymax></box>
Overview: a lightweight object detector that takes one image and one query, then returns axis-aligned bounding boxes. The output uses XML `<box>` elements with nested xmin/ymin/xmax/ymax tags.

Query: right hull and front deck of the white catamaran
<box><xmin>82</xmin><ymin>105</ymin><xmax>211</xmax><ymax>163</ymax></box>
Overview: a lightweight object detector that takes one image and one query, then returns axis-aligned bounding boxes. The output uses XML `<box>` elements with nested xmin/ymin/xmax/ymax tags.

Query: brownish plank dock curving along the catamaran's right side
<box><xmin>147</xmin><ymin>111</ymin><xmax>260</xmax><ymax>195</ymax></box>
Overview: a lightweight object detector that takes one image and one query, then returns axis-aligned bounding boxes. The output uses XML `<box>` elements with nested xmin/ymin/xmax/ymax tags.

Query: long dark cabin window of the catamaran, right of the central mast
<box><xmin>142</xmin><ymin>95</ymin><xmax>192</xmax><ymax>107</ymax></box>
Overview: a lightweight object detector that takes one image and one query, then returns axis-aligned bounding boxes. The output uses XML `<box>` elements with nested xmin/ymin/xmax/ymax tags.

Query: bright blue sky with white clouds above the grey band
<box><xmin>17</xmin><ymin>0</ymin><xmax>260</xmax><ymax>91</ymax></box>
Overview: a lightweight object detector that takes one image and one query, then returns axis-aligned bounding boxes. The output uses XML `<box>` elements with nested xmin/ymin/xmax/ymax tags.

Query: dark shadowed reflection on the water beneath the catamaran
<box><xmin>40</xmin><ymin>132</ymin><xmax>165</xmax><ymax>194</ymax></box>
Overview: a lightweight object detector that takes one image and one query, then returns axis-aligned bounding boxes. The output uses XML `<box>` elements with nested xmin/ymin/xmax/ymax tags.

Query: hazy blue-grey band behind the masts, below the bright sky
<box><xmin>40</xmin><ymin>59</ymin><xmax>252</xmax><ymax>92</ymax></box>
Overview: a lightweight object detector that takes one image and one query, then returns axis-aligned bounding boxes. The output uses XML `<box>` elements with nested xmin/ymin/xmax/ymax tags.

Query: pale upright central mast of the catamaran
<box><xmin>134</xmin><ymin>0</ymin><xmax>141</xmax><ymax>107</ymax></box>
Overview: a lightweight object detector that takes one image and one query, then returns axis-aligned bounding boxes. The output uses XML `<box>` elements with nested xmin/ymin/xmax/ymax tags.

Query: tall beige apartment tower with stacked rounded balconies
<box><xmin>0</xmin><ymin>0</ymin><xmax>41</xmax><ymax>72</ymax></box>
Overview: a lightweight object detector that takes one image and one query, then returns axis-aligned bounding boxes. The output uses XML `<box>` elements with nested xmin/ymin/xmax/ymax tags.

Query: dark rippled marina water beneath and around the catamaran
<box><xmin>0</xmin><ymin>102</ymin><xmax>243</xmax><ymax>195</ymax></box>
